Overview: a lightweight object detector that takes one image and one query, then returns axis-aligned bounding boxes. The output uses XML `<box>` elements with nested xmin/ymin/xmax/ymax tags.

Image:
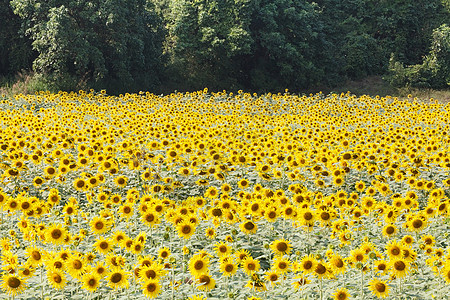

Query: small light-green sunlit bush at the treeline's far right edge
<box><xmin>387</xmin><ymin>24</ymin><xmax>450</xmax><ymax>88</ymax></box>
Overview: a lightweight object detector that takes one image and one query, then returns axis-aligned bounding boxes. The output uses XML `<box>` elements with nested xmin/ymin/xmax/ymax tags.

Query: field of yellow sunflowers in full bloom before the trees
<box><xmin>0</xmin><ymin>90</ymin><xmax>450</xmax><ymax>300</ymax></box>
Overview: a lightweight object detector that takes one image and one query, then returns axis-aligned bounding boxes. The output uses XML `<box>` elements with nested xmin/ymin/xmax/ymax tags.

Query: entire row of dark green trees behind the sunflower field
<box><xmin>0</xmin><ymin>0</ymin><xmax>450</xmax><ymax>92</ymax></box>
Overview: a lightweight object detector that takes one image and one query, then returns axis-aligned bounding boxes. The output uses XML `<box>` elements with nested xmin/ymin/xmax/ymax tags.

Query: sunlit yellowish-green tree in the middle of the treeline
<box><xmin>167</xmin><ymin>0</ymin><xmax>253</xmax><ymax>89</ymax></box>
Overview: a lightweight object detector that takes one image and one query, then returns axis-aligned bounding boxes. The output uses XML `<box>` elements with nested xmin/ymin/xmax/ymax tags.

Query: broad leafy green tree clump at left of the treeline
<box><xmin>11</xmin><ymin>0</ymin><xmax>164</xmax><ymax>93</ymax></box>
